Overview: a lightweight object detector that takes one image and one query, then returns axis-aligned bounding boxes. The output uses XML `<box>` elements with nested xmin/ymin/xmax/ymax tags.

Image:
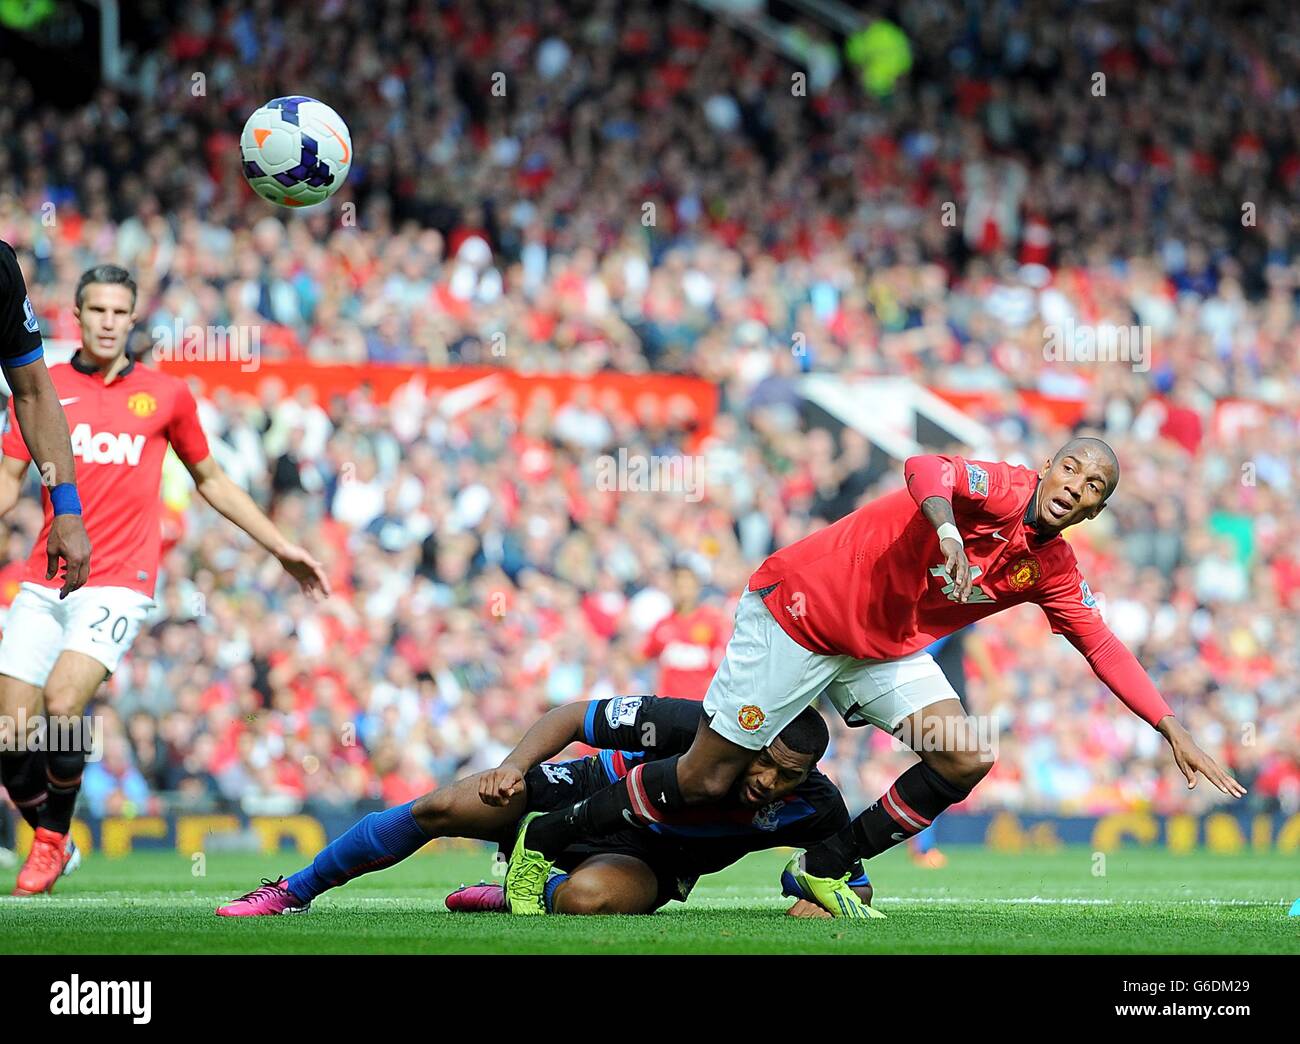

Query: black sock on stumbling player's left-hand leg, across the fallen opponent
<box><xmin>528</xmin><ymin>757</ymin><xmax>685</xmax><ymax>859</ymax></box>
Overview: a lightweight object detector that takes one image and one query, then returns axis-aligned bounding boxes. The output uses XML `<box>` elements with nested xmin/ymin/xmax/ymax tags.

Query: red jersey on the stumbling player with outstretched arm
<box><xmin>749</xmin><ymin>456</ymin><xmax>1105</xmax><ymax>659</ymax></box>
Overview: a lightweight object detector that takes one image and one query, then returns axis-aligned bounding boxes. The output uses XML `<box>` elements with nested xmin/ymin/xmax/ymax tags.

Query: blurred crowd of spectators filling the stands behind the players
<box><xmin>0</xmin><ymin>0</ymin><xmax>1300</xmax><ymax>814</ymax></box>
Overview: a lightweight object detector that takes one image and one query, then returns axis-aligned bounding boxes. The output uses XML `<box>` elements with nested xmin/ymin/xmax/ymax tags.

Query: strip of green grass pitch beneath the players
<box><xmin>0</xmin><ymin>846</ymin><xmax>1300</xmax><ymax>953</ymax></box>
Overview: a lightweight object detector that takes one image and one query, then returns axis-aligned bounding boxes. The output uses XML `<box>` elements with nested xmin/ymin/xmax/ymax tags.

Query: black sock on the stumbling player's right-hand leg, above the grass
<box><xmin>803</xmin><ymin>762</ymin><xmax>970</xmax><ymax>878</ymax></box>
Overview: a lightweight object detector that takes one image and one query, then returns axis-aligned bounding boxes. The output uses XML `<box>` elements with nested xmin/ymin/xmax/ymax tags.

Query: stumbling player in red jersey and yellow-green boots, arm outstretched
<box><xmin>506</xmin><ymin>438</ymin><xmax>1245</xmax><ymax>917</ymax></box>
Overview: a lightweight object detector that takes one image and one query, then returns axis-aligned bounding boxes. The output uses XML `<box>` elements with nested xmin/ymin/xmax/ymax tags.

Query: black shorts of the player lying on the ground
<box><xmin>520</xmin><ymin>755</ymin><xmax>699</xmax><ymax>910</ymax></box>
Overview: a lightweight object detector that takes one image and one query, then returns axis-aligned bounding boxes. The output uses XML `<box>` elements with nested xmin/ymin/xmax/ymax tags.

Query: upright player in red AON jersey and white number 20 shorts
<box><xmin>0</xmin><ymin>265</ymin><xmax>329</xmax><ymax>896</ymax></box>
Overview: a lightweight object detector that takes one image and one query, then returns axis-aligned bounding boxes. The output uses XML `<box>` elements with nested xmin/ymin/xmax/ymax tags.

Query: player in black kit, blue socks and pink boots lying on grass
<box><xmin>217</xmin><ymin>696</ymin><xmax>883</xmax><ymax>917</ymax></box>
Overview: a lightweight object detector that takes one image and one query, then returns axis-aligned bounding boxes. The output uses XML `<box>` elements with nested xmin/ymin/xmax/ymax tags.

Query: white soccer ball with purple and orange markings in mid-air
<box><xmin>239</xmin><ymin>96</ymin><xmax>352</xmax><ymax>207</ymax></box>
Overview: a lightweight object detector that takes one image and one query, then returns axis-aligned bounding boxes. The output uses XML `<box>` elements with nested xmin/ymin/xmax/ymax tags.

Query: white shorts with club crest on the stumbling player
<box><xmin>705</xmin><ymin>590</ymin><xmax>957</xmax><ymax>750</ymax></box>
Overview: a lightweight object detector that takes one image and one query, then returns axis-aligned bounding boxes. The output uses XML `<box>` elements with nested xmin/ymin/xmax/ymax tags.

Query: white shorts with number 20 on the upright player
<box><xmin>0</xmin><ymin>581</ymin><xmax>153</xmax><ymax>688</ymax></box>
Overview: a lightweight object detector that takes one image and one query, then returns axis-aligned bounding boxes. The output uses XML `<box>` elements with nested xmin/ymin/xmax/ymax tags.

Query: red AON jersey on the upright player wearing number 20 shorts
<box><xmin>3</xmin><ymin>359</ymin><xmax>208</xmax><ymax>598</ymax></box>
